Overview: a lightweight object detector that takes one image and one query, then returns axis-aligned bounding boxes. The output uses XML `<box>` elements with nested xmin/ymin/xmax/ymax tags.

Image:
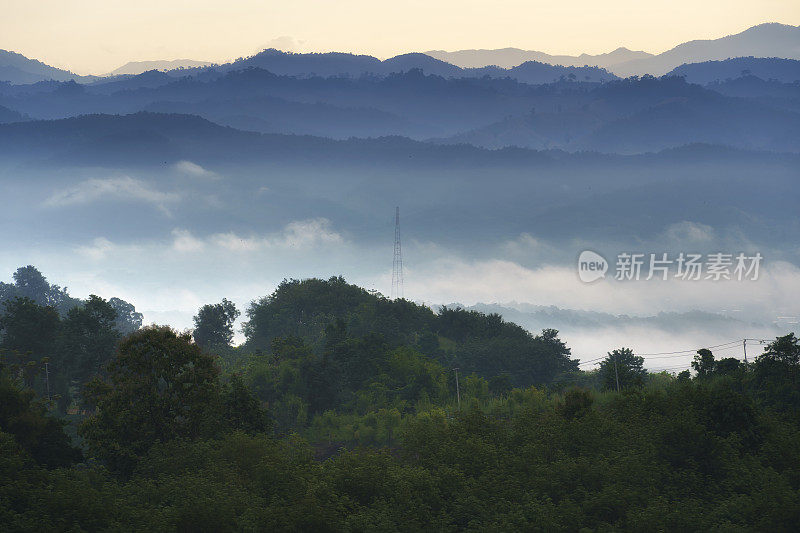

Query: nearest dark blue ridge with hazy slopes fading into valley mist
<box><xmin>0</xmin><ymin>113</ymin><xmax>800</xmax><ymax>261</ymax></box>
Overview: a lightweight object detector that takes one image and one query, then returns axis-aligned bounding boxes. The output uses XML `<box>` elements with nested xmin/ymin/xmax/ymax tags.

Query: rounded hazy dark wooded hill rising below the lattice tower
<box><xmin>244</xmin><ymin>277</ymin><xmax>578</xmax><ymax>386</ymax></box>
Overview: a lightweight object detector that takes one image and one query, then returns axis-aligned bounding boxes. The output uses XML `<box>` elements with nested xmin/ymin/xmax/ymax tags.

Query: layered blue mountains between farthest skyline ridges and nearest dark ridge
<box><xmin>0</xmin><ymin>68</ymin><xmax>800</xmax><ymax>153</ymax></box>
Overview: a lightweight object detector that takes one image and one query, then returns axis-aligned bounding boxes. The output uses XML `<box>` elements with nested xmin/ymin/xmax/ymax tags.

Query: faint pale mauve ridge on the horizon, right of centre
<box><xmin>425</xmin><ymin>47</ymin><xmax>653</xmax><ymax>70</ymax></box>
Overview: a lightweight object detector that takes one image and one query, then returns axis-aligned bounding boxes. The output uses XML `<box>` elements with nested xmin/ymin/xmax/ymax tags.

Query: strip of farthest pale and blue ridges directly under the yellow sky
<box><xmin>0</xmin><ymin>23</ymin><xmax>800</xmax><ymax>84</ymax></box>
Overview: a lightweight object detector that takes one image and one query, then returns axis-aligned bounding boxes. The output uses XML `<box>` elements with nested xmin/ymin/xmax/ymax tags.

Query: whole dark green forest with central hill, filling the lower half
<box><xmin>0</xmin><ymin>272</ymin><xmax>800</xmax><ymax>531</ymax></box>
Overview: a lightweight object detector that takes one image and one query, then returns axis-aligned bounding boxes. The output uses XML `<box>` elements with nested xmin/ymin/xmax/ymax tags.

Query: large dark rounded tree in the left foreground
<box><xmin>80</xmin><ymin>327</ymin><xmax>268</xmax><ymax>473</ymax></box>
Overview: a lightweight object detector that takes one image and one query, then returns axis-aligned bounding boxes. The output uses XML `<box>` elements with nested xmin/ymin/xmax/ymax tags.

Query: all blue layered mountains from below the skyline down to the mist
<box><xmin>0</xmin><ymin>22</ymin><xmax>800</xmax><ymax>245</ymax></box>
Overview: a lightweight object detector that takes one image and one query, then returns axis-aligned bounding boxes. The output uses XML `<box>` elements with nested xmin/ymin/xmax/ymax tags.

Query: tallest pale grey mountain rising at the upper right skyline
<box><xmin>611</xmin><ymin>23</ymin><xmax>800</xmax><ymax>77</ymax></box>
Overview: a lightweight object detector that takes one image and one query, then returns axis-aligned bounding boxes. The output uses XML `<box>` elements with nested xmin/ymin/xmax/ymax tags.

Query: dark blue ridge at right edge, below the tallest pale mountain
<box><xmin>669</xmin><ymin>57</ymin><xmax>800</xmax><ymax>85</ymax></box>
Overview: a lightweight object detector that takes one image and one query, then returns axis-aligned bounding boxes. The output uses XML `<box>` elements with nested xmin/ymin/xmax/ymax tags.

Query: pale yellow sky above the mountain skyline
<box><xmin>0</xmin><ymin>0</ymin><xmax>800</xmax><ymax>74</ymax></box>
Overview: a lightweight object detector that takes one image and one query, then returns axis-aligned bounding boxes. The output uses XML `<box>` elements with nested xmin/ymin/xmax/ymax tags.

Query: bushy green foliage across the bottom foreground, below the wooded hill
<box><xmin>0</xmin><ymin>356</ymin><xmax>800</xmax><ymax>531</ymax></box>
